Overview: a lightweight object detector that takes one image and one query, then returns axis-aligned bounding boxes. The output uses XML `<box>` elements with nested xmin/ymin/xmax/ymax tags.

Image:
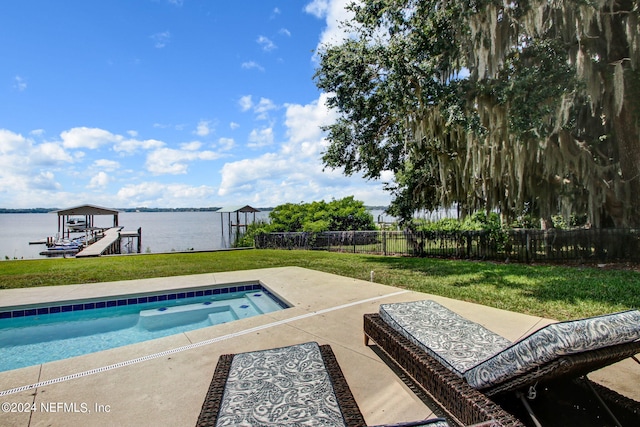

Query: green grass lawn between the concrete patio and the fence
<box><xmin>0</xmin><ymin>250</ymin><xmax>640</xmax><ymax>320</ymax></box>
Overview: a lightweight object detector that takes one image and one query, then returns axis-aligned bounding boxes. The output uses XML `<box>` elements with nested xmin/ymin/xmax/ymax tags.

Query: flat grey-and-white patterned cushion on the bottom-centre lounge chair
<box><xmin>217</xmin><ymin>342</ymin><xmax>345</xmax><ymax>426</ymax></box>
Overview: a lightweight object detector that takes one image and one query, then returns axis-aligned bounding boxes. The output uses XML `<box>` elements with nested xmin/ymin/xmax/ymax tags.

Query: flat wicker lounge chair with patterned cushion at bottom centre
<box><xmin>197</xmin><ymin>342</ymin><xmax>448</xmax><ymax>427</ymax></box>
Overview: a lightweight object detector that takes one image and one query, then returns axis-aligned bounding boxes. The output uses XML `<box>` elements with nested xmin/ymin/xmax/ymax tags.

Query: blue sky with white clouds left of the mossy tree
<box><xmin>0</xmin><ymin>0</ymin><xmax>389</xmax><ymax>208</ymax></box>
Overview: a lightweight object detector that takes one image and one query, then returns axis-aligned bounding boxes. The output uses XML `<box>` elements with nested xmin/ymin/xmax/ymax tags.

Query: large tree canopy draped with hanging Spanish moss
<box><xmin>316</xmin><ymin>0</ymin><xmax>640</xmax><ymax>227</ymax></box>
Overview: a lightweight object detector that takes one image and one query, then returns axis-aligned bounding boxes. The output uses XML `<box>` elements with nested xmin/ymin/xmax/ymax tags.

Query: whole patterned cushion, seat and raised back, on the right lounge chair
<box><xmin>380</xmin><ymin>300</ymin><xmax>640</xmax><ymax>389</ymax></box>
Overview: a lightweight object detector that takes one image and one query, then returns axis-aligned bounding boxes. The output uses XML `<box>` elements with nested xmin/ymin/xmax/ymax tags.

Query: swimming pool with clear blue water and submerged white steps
<box><xmin>0</xmin><ymin>283</ymin><xmax>289</xmax><ymax>371</ymax></box>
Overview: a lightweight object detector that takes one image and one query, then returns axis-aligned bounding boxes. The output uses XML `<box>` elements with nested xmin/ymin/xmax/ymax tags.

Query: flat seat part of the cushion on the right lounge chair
<box><xmin>379</xmin><ymin>300</ymin><xmax>511</xmax><ymax>376</ymax></box>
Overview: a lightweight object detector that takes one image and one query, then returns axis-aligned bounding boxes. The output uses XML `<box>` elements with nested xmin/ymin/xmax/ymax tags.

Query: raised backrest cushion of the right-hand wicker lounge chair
<box><xmin>464</xmin><ymin>310</ymin><xmax>640</xmax><ymax>389</ymax></box>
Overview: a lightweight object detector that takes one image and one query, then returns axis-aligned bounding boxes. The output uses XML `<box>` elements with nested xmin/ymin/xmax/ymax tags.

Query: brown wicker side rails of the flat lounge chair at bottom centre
<box><xmin>196</xmin><ymin>345</ymin><xmax>366</xmax><ymax>427</ymax></box>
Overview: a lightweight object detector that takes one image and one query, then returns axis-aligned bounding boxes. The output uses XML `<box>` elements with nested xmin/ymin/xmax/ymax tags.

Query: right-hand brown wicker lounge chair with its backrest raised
<box><xmin>364</xmin><ymin>301</ymin><xmax>640</xmax><ymax>425</ymax></box>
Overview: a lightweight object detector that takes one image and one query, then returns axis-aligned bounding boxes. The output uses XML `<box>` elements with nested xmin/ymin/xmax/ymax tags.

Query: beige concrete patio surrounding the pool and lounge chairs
<box><xmin>0</xmin><ymin>267</ymin><xmax>640</xmax><ymax>426</ymax></box>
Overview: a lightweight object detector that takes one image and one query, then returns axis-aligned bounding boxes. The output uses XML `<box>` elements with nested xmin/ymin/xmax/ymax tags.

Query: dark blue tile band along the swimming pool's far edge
<box><xmin>0</xmin><ymin>283</ymin><xmax>291</xmax><ymax>320</ymax></box>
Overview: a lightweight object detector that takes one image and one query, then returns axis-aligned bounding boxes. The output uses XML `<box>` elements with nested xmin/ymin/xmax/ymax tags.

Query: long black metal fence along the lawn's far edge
<box><xmin>255</xmin><ymin>229</ymin><xmax>640</xmax><ymax>263</ymax></box>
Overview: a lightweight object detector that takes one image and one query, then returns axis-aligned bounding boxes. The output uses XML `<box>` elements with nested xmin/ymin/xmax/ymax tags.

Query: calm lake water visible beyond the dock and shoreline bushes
<box><xmin>0</xmin><ymin>211</ymin><xmax>392</xmax><ymax>260</ymax></box>
